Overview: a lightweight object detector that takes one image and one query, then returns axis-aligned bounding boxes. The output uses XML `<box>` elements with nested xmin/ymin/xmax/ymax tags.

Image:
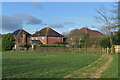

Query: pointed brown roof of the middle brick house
<box><xmin>32</xmin><ymin>27</ymin><xmax>63</xmax><ymax>37</ymax></box>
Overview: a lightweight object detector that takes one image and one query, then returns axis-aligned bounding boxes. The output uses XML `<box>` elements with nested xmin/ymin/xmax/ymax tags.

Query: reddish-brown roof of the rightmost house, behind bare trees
<box><xmin>79</xmin><ymin>27</ymin><xmax>105</xmax><ymax>37</ymax></box>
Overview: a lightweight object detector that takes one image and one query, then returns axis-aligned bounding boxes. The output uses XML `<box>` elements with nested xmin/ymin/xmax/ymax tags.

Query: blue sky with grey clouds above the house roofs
<box><xmin>0</xmin><ymin>2</ymin><xmax>112</xmax><ymax>34</ymax></box>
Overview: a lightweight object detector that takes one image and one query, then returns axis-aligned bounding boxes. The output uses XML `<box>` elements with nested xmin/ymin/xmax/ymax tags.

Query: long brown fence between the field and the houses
<box><xmin>34</xmin><ymin>47</ymin><xmax>103</xmax><ymax>53</ymax></box>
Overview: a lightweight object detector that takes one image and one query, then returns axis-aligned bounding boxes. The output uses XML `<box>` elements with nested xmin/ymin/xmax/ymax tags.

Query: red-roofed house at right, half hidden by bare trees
<box><xmin>68</xmin><ymin>27</ymin><xmax>105</xmax><ymax>47</ymax></box>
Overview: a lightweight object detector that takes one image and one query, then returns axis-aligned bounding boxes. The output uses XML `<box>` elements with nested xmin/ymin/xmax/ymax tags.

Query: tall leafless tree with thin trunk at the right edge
<box><xmin>94</xmin><ymin>3</ymin><xmax>119</xmax><ymax>52</ymax></box>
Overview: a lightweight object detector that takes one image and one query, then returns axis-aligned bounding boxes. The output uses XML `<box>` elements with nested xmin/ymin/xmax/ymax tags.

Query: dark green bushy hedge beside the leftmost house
<box><xmin>2</xmin><ymin>33</ymin><xmax>15</xmax><ymax>51</ymax></box>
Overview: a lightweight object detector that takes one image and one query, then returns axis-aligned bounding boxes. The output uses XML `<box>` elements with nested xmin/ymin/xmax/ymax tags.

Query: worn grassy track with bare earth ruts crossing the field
<box><xmin>64</xmin><ymin>54</ymin><xmax>113</xmax><ymax>78</ymax></box>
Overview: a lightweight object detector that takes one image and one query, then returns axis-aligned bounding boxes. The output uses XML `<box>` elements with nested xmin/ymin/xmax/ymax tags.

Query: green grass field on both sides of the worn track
<box><xmin>2</xmin><ymin>52</ymin><xmax>118</xmax><ymax>78</ymax></box>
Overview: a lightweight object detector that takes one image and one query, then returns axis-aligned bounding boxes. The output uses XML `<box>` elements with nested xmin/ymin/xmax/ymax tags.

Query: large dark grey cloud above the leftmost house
<box><xmin>0</xmin><ymin>14</ymin><xmax>42</xmax><ymax>31</ymax></box>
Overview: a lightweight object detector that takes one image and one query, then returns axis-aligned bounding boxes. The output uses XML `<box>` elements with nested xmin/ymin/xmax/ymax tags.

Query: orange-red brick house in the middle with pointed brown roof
<box><xmin>30</xmin><ymin>27</ymin><xmax>64</xmax><ymax>44</ymax></box>
